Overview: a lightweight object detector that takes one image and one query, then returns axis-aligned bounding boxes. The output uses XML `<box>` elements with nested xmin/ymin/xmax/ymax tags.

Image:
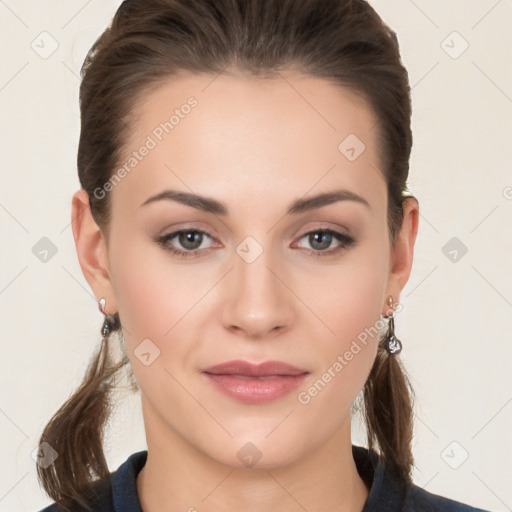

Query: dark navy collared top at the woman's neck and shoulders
<box><xmin>39</xmin><ymin>445</ymin><xmax>489</xmax><ymax>512</ymax></box>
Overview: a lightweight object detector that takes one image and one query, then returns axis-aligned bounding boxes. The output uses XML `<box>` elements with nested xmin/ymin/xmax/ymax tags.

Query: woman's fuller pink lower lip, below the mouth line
<box><xmin>204</xmin><ymin>373</ymin><xmax>307</xmax><ymax>404</ymax></box>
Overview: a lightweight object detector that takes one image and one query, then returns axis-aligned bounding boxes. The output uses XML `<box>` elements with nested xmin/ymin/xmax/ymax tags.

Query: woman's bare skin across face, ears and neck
<box><xmin>72</xmin><ymin>72</ymin><xmax>419</xmax><ymax>512</ymax></box>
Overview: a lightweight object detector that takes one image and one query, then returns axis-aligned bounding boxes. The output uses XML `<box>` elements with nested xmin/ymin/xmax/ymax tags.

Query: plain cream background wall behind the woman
<box><xmin>0</xmin><ymin>0</ymin><xmax>512</xmax><ymax>512</ymax></box>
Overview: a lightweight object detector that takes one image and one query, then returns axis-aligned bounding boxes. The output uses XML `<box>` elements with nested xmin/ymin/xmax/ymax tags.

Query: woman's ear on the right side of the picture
<box><xmin>382</xmin><ymin>197</ymin><xmax>419</xmax><ymax>315</ymax></box>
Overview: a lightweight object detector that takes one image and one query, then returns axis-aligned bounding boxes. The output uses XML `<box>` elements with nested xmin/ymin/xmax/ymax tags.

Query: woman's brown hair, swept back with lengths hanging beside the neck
<box><xmin>37</xmin><ymin>0</ymin><xmax>414</xmax><ymax>510</ymax></box>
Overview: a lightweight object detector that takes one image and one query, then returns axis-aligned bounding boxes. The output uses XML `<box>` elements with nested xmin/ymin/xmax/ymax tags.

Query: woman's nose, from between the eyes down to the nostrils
<box><xmin>224</xmin><ymin>236</ymin><xmax>292</xmax><ymax>336</ymax></box>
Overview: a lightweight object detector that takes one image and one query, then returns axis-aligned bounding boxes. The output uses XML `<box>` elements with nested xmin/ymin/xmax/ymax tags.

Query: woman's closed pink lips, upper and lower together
<box><xmin>202</xmin><ymin>360</ymin><xmax>309</xmax><ymax>404</ymax></box>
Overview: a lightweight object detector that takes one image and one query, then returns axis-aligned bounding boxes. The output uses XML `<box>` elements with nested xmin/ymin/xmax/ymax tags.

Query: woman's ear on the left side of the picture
<box><xmin>71</xmin><ymin>189</ymin><xmax>117</xmax><ymax>314</ymax></box>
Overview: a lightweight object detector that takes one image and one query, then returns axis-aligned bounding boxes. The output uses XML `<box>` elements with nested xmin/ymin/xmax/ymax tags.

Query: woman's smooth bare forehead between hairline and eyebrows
<box><xmin>114</xmin><ymin>72</ymin><xmax>385</xmax><ymax>216</ymax></box>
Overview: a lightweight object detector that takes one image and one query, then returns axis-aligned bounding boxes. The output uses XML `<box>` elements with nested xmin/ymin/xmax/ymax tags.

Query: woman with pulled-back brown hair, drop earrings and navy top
<box><xmin>37</xmin><ymin>0</ymin><xmax>492</xmax><ymax>512</ymax></box>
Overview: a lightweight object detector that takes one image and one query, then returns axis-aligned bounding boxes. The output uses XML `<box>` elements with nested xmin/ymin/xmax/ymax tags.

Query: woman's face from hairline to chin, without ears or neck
<box><xmin>99</xmin><ymin>73</ymin><xmax>391</xmax><ymax>468</ymax></box>
